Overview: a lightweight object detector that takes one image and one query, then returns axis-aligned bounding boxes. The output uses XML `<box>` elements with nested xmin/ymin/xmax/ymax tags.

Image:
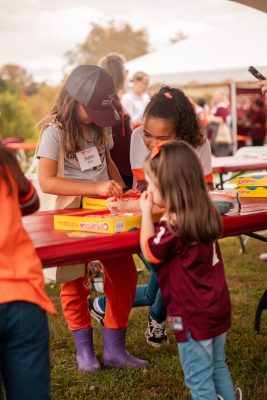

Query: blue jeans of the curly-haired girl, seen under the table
<box><xmin>98</xmin><ymin>254</ymin><xmax>167</xmax><ymax>322</ymax></box>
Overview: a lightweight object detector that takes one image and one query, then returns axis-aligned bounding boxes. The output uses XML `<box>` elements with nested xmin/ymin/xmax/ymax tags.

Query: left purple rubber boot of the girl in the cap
<box><xmin>72</xmin><ymin>328</ymin><xmax>100</xmax><ymax>372</ymax></box>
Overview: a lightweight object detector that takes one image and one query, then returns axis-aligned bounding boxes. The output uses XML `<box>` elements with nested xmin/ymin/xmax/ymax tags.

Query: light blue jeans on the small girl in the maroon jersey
<box><xmin>180</xmin><ymin>333</ymin><xmax>235</xmax><ymax>400</ymax></box>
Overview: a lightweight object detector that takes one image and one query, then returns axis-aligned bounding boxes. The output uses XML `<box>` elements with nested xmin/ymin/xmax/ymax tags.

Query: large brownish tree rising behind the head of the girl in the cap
<box><xmin>65</xmin><ymin>20</ymin><xmax>149</xmax><ymax>66</ymax></box>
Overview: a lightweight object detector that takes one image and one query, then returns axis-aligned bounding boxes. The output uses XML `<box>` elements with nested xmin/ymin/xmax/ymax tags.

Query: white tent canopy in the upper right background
<box><xmin>127</xmin><ymin>8</ymin><xmax>267</xmax><ymax>85</ymax></box>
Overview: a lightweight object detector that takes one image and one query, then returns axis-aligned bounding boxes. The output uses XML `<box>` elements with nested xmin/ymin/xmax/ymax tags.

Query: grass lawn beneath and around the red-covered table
<box><xmin>48</xmin><ymin>238</ymin><xmax>267</xmax><ymax>400</ymax></box>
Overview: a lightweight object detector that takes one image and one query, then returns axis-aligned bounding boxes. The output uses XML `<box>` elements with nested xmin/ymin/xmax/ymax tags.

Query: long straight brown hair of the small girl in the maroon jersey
<box><xmin>145</xmin><ymin>140</ymin><xmax>222</xmax><ymax>245</ymax></box>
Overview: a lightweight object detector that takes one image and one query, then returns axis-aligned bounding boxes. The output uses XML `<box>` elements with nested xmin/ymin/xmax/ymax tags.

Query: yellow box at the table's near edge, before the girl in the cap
<box><xmin>54</xmin><ymin>210</ymin><xmax>163</xmax><ymax>233</ymax></box>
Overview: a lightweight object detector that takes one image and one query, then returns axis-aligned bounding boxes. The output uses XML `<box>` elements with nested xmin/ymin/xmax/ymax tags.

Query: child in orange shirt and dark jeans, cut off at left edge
<box><xmin>0</xmin><ymin>145</ymin><xmax>56</xmax><ymax>400</ymax></box>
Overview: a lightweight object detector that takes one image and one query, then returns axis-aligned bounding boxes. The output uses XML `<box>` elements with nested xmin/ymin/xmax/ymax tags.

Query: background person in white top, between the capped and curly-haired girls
<box><xmin>121</xmin><ymin>71</ymin><xmax>150</xmax><ymax>128</ymax></box>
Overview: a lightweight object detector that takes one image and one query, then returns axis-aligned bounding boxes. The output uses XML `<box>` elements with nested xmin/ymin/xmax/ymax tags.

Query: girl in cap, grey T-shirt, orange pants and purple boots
<box><xmin>37</xmin><ymin>65</ymin><xmax>148</xmax><ymax>372</ymax></box>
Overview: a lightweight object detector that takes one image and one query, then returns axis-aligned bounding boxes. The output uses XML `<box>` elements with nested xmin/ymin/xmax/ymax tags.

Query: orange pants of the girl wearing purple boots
<box><xmin>60</xmin><ymin>255</ymin><xmax>137</xmax><ymax>330</ymax></box>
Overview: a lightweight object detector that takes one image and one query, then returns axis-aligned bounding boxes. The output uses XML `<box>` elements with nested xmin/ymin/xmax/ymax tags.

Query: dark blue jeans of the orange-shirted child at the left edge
<box><xmin>0</xmin><ymin>301</ymin><xmax>50</xmax><ymax>400</ymax></box>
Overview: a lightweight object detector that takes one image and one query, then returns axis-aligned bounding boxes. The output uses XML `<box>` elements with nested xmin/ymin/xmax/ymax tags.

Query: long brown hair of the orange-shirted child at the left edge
<box><xmin>0</xmin><ymin>144</ymin><xmax>27</xmax><ymax>195</ymax></box>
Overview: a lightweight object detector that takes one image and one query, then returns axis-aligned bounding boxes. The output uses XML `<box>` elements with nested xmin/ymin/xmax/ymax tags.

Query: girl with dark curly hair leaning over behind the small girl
<box><xmin>89</xmin><ymin>86</ymin><xmax>213</xmax><ymax>347</ymax></box>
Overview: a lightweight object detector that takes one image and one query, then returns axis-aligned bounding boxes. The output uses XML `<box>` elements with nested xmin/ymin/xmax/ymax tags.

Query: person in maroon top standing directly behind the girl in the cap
<box><xmin>98</xmin><ymin>53</ymin><xmax>133</xmax><ymax>189</ymax></box>
